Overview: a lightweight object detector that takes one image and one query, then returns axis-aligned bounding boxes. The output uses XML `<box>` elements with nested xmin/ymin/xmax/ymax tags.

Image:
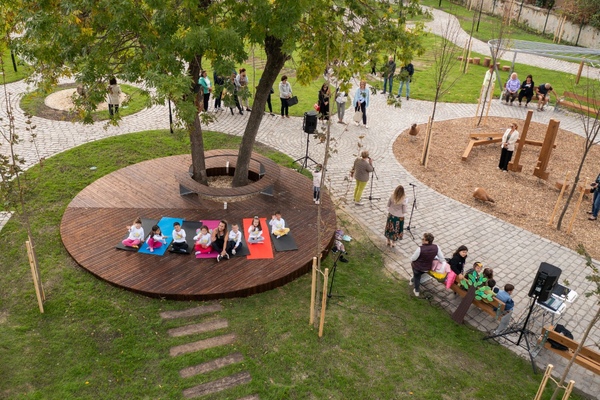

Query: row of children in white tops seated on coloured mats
<box><xmin>122</xmin><ymin>211</ymin><xmax>290</xmax><ymax>262</ymax></box>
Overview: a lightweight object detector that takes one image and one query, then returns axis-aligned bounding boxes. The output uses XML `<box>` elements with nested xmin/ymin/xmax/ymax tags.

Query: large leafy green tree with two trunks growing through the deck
<box><xmin>19</xmin><ymin>0</ymin><xmax>420</xmax><ymax>186</ymax></box>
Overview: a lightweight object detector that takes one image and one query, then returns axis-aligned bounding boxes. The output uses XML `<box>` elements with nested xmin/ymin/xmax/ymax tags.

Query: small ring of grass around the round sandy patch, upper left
<box><xmin>19</xmin><ymin>83</ymin><xmax>151</xmax><ymax>121</ymax></box>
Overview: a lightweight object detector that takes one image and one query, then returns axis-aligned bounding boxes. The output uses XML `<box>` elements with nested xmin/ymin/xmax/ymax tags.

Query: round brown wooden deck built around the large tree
<box><xmin>60</xmin><ymin>155</ymin><xmax>336</xmax><ymax>300</ymax></box>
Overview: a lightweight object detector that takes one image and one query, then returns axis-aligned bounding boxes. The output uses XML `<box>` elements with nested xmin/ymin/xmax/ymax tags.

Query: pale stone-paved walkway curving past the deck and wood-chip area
<box><xmin>0</xmin><ymin>16</ymin><xmax>600</xmax><ymax>393</ymax></box>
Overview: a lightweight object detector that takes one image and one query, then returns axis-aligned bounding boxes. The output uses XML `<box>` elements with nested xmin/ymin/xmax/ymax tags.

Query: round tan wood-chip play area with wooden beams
<box><xmin>393</xmin><ymin>117</ymin><xmax>600</xmax><ymax>259</ymax></box>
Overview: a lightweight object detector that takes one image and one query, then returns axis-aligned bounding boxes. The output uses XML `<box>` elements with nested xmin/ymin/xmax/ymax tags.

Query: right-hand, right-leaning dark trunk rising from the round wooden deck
<box><xmin>232</xmin><ymin>36</ymin><xmax>289</xmax><ymax>187</ymax></box>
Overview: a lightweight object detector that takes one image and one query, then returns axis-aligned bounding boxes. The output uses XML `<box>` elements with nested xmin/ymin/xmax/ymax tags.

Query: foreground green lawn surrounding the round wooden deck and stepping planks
<box><xmin>0</xmin><ymin>131</ymin><xmax>577</xmax><ymax>400</ymax></box>
